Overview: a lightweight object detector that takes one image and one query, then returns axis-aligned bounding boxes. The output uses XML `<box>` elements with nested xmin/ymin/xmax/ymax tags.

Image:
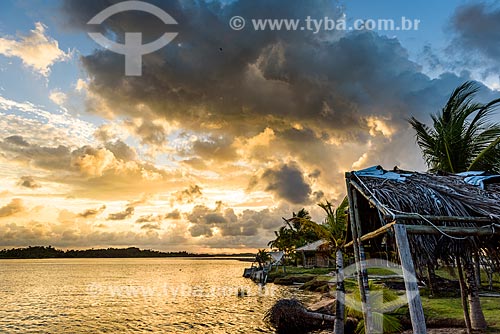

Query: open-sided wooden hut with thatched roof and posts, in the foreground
<box><xmin>346</xmin><ymin>166</ymin><xmax>500</xmax><ymax>334</ymax></box>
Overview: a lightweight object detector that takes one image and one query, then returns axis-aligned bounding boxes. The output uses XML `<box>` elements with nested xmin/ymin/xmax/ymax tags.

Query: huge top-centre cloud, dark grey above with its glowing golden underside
<box><xmin>57</xmin><ymin>0</ymin><xmax>484</xmax><ymax>185</ymax></box>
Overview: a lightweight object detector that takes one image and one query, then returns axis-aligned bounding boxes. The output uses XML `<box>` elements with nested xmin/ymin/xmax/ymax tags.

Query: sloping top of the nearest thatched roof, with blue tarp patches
<box><xmin>354</xmin><ymin>166</ymin><xmax>500</xmax><ymax>221</ymax></box>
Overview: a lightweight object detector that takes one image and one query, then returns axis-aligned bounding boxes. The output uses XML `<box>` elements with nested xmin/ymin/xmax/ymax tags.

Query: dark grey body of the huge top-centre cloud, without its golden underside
<box><xmin>59</xmin><ymin>0</ymin><xmax>434</xmax><ymax>138</ymax></box>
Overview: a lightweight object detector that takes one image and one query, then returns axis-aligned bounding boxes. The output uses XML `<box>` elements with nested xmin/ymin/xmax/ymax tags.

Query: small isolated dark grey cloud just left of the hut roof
<box><xmin>261</xmin><ymin>163</ymin><xmax>311</xmax><ymax>204</ymax></box>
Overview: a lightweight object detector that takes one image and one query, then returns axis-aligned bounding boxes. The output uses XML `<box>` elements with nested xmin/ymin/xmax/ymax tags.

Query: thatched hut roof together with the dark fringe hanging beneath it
<box><xmin>349</xmin><ymin>166</ymin><xmax>500</xmax><ymax>263</ymax></box>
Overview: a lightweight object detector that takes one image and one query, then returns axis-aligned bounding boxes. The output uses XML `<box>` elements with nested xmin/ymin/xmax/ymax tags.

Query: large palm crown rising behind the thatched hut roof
<box><xmin>409</xmin><ymin>81</ymin><xmax>500</xmax><ymax>173</ymax></box>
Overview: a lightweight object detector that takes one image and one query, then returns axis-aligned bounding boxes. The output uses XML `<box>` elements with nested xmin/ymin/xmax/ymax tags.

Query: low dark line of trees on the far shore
<box><xmin>0</xmin><ymin>246</ymin><xmax>252</xmax><ymax>259</ymax></box>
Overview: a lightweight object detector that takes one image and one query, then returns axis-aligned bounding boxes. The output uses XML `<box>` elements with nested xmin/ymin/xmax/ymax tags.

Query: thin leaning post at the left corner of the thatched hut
<box><xmin>346</xmin><ymin>178</ymin><xmax>373</xmax><ymax>334</ymax></box>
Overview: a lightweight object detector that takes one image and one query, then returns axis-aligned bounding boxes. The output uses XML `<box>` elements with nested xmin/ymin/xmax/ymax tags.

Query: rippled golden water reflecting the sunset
<box><xmin>0</xmin><ymin>259</ymin><xmax>317</xmax><ymax>334</ymax></box>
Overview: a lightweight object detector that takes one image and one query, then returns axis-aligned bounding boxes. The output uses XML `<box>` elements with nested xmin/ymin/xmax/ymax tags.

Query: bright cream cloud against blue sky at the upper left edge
<box><xmin>0</xmin><ymin>22</ymin><xmax>70</xmax><ymax>76</ymax></box>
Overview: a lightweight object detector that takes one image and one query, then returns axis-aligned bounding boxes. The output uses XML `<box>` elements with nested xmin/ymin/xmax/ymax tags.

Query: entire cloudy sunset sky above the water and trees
<box><xmin>0</xmin><ymin>0</ymin><xmax>500</xmax><ymax>253</ymax></box>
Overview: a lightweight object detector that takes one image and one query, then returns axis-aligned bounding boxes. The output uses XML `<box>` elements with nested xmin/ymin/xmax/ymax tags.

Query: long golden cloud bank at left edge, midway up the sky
<box><xmin>0</xmin><ymin>136</ymin><xmax>188</xmax><ymax>199</ymax></box>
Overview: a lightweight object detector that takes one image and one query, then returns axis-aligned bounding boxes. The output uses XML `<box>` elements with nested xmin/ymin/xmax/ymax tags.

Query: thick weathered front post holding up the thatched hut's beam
<box><xmin>394</xmin><ymin>224</ymin><xmax>427</xmax><ymax>334</ymax></box>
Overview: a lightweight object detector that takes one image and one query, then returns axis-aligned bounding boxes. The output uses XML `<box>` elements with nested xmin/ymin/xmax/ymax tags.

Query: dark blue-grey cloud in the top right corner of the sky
<box><xmin>451</xmin><ymin>2</ymin><xmax>500</xmax><ymax>66</ymax></box>
